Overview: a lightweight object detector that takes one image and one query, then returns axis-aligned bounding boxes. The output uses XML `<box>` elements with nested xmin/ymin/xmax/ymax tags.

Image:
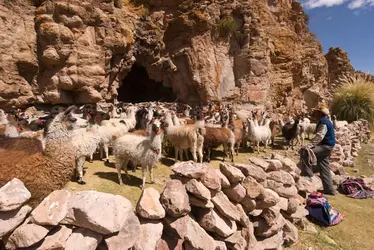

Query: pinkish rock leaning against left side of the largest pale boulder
<box><xmin>31</xmin><ymin>190</ymin><xmax>71</xmax><ymax>226</ymax></box>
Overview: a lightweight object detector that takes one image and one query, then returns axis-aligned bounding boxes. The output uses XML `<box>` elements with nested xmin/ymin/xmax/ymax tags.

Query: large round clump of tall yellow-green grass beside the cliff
<box><xmin>331</xmin><ymin>79</ymin><xmax>374</xmax><ymax>124</ymax></box>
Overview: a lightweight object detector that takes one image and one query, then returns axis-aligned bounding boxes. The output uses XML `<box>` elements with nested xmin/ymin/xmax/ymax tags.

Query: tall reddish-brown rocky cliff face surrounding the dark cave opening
<box><xmin>0</xmin><ymin>0</ymin><xmax>329</xmax><ymax>108</ymax></box>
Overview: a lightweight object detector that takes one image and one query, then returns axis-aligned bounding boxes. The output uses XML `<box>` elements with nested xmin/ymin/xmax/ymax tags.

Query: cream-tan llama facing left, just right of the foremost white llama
<box><xmin>163</xmin><ymin>112</ymin><xmax>205</xmax><ymax>162</ymax></box>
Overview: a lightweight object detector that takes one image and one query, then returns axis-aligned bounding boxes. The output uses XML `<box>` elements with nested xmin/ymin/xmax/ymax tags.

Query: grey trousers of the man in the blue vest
<box><xmin>312</xmin><ymin>145</ymin><xmax>334</xmax><ymax>193</ymax></box>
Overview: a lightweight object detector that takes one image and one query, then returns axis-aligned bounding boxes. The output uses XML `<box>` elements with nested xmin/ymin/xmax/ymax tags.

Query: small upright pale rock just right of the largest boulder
<box><xmin>136</xmin><ymin>187</ymin><xmax>165</xmax><ymax>219</ymax></box>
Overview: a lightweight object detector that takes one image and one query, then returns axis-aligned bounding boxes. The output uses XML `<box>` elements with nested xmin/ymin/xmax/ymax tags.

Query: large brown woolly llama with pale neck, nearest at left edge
<box><xmin>0</xmin><ymin>106</ymin><xmax>87</xmax><ymax>205</ymax></box>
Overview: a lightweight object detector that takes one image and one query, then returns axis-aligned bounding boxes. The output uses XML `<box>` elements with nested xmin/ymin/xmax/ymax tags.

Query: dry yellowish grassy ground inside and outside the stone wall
<box><xmin>67</xmin><ymin>139</ymin><xmax>374</xmax><ymax>250</ymax></box>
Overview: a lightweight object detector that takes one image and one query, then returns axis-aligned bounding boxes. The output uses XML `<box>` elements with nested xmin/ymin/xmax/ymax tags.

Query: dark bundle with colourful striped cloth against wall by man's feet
<box><xmin>305</xmin><ymin>192</ymin><xmax>344</xmax><ymax>226</ymax></box>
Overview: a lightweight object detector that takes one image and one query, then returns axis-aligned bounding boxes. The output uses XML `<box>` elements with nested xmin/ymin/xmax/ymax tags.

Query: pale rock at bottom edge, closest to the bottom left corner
<box><xmin>5</xmin><ymin>223</ymin><xmax>51</xmax><ymax>250</ymax></box>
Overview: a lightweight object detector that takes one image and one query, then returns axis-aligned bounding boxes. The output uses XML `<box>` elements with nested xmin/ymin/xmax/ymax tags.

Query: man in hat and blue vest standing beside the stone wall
<box><xmin>306</xmin><ymin>105</ymin><xmax>336</xmax><ymax>195</ymax></box>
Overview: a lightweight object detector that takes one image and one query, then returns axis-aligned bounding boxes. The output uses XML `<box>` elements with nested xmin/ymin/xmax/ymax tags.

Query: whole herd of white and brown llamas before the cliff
<box><xmin>0</xmin><ymin>100</ymin><xmax>347</xmax><ymax>206</ymax></box>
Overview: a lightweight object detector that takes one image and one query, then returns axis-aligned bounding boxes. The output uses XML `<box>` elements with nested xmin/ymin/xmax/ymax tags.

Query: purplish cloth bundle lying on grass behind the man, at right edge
<box><xmin>339</xmin><ymin>178</ymin><xmax>374</xmax><ymax>199</ymax></box>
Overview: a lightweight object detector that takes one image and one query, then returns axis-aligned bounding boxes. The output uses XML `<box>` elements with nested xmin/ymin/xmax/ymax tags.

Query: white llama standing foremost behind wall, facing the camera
<box><xmin>113</xmin><ymin>120</ymin><xmax>162</xmax><ymax>189</ymax></box>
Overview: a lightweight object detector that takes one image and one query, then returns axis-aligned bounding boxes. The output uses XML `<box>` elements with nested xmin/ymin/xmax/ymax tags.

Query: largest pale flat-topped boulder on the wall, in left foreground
<box><xmin>61</xmin><ymin>191</ymin><xmax>133</xmax><ymax>234</ymax></box>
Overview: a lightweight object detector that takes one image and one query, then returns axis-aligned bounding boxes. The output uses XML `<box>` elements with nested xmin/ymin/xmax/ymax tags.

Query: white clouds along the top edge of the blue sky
<box><xmin>303</xmin><ymin>0</ymin><xmax>374</xmax><ymax>9</ymax></box>
